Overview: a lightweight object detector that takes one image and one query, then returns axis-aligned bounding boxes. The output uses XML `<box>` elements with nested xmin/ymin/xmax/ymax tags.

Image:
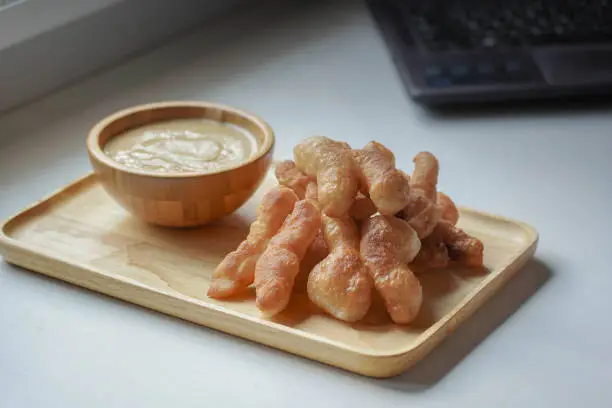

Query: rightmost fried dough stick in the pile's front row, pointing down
<box><xmin>360</xmin><ymin>215</ymin><xmax>423</xmax><ymax>324</ymax></box>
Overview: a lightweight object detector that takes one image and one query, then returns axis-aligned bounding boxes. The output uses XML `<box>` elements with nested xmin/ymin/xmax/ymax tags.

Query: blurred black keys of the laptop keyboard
<box><xmin>390</xmin><ymin>0</ymin><xmax>612</xmax><ymax>51</ymax></box>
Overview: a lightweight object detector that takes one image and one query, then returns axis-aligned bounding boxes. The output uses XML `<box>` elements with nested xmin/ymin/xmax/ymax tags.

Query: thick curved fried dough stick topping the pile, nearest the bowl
<box><xmin>293</xmin><ymin>136</ymin><xmax>358</xmax><ymax>217</ymax></box>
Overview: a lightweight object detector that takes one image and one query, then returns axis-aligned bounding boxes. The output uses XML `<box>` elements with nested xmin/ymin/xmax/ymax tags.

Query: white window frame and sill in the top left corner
<box><xmin>0</xmin><ymin>0</ymin><xmax>255</xmax><ymax>115</ymax></box>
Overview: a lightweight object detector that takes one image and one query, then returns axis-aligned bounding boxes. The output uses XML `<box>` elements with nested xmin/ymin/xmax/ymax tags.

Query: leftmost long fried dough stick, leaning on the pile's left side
<box><xmin>208</xmin><ymin>186</ymin><xmax>298</xmax><ymax>299</ymax></box>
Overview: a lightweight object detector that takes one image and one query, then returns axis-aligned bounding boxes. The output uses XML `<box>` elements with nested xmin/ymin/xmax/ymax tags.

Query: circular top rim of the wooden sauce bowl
<box><xmin>87</xmin><ymin>100</ymin><xmax>276</xmax><ymax>179</ymax></box>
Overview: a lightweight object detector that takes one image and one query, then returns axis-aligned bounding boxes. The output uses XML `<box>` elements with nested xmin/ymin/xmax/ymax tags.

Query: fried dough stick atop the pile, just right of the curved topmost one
<box><xmin>353</xmin><ymin>142</ymin><xmax>410</xmax><ymax>215</ymax></box>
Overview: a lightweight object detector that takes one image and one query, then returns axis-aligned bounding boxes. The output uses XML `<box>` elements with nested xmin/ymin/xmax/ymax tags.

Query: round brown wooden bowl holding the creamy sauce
<box><xmin>87</xmin><ymin>102</ymin><xmax>274</xmax><ymax>227</ymax></box>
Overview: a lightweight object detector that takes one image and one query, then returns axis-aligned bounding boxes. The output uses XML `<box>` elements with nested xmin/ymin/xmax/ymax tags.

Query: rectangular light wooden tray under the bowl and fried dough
<box><xmin>0</xmin><ymin>167</ymin><xmax>537</xmax><ymax>377</ymax></box>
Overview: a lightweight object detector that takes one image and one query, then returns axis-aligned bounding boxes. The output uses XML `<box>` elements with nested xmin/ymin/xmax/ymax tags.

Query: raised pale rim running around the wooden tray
<box><xmin>0</xmin><ymin>172</ymin><xmax>539</xmax><ymax>377</ymax></box>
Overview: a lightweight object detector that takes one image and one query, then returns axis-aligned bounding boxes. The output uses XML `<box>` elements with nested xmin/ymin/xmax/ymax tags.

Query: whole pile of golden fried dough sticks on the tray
<box><xmin>208</xmin><ymin>136</ymin><xmax>484</xmax><ymax>324</ymax></box>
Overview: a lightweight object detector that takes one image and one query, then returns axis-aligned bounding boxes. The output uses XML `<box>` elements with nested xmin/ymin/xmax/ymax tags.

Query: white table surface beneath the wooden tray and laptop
<box><xmin>0</xmin><ymin>3</ymin><xmax>612</xmax><ymax>408</ymax></box>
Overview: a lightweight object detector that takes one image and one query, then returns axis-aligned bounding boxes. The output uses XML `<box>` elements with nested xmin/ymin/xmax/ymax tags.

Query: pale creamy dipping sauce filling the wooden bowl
<box><xmin>104</xmin><ymin>118</ymin><xmax>257</xmax><ymax>173</ymax></box>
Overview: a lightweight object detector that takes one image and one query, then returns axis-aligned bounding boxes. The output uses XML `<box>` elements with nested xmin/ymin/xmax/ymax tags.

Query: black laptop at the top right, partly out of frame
<box><xmin>366</xmin><ymin>0</ymin><xmax>612</xmax><ymax>105</ymax></box>
